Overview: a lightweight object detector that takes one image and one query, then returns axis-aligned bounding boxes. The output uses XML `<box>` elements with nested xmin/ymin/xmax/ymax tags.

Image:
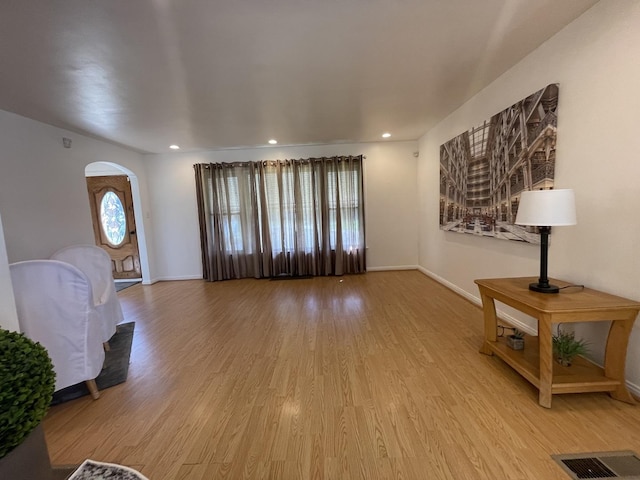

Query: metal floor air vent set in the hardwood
<box><xmin>551</xmin><ymin>451</ymin><xmax>640</xmax><ymax>480</ymax></box>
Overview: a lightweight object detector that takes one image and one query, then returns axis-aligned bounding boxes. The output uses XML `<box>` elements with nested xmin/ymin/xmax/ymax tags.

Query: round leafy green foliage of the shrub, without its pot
<box><xmin>0</xmin><ymin>329</ymin><xmax>56</xmax><ymax>458</ymax></box>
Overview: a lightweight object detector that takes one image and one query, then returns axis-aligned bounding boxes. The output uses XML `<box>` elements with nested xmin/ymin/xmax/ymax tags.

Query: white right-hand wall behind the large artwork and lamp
<box><xmin>418</xmin><ymin>0</ymin><xmax>640</xmax><ymax>389</ymax></box>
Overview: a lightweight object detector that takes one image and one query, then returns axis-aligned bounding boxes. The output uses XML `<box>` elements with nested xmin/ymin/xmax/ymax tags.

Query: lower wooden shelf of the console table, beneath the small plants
<box><xmin>482</xmin><ymin>336</ymin><xmax>620</xmax><ymax>395</ymax></box>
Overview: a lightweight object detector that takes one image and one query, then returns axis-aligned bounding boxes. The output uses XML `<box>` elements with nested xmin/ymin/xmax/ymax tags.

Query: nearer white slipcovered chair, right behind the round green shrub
<box><xmin>9</xmin><ymin>260</ymin><xmax>104</xmax><ymax>398</ymax></box>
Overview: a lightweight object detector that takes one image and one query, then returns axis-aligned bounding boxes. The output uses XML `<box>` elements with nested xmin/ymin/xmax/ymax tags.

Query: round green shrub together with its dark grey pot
<box><xmin>0</xmin><ymin>328</ymin><xmax>55</xmax><ymax>480</ymax></box>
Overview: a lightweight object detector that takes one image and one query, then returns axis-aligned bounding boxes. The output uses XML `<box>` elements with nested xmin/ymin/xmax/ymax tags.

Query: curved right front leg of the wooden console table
<box><xmin>604</xmin><ymin>312</ymin><xmax>637</xmax><ymax>404</ymax></box>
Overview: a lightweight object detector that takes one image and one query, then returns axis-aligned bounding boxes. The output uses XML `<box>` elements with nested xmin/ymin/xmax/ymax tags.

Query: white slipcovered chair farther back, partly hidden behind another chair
<box><xmin>51</xmin><ymin>245</ymin><xmax>124</xmax><ymax>349</ymax></box>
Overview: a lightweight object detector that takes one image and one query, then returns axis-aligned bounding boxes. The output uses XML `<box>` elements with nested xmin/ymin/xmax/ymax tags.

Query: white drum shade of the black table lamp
<box><xmin>514</xmin><ymin>189</ymin><xmax>576</xmax><ymax>227</ymax></box>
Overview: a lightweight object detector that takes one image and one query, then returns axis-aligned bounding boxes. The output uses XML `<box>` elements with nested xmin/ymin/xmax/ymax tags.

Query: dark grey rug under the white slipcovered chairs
<box><xmin>51</xmin><ymin>322</ymin><xmax>135</xmax><ymax>406</ymax></box>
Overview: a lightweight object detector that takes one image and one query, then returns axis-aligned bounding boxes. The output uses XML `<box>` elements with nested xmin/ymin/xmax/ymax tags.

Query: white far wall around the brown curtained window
<box><xmin>145</xmin><ymin>142</ymin><xmax>418</xmax><ymax>280</ymax></box>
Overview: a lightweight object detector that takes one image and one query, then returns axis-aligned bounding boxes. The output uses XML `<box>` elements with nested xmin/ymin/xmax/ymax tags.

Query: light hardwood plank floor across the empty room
<box><xmin>44</xmin><ymin>271</ymin><xmax>640</xmax><ymax>480</ymax></box>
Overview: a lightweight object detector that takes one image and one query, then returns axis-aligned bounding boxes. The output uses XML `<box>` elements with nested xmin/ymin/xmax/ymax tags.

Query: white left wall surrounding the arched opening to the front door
<box><xmin>0</xmin><ymin>111</ymin><xmax>148</xmax><ymax>276</ymax></box>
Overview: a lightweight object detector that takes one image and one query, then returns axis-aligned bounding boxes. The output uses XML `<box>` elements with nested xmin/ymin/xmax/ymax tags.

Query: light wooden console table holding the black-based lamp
<box><xmin>475</xmin><ymin>277</ymin><xmax>640</xmax><ymax>408</ymax></box>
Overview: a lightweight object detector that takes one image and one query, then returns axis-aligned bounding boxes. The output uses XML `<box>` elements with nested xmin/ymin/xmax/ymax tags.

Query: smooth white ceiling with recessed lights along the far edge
<box><xmin>0</xmin><ymin>0</ymin><xmax>597</xmax><ymax>152</ymax></box>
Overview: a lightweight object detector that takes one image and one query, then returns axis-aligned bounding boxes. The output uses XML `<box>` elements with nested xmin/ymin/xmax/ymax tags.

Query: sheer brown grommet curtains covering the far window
<box><xmin>194</xmin><ymin>156</ymin><xmax>366</xmax><ymax>281</ymax></box>
